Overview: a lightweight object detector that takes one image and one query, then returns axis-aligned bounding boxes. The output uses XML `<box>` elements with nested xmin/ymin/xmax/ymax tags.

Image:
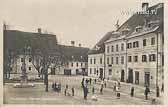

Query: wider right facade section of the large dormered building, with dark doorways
<box><xmin>127</xmin><ymin>33</ymin><xmax>163</xmax><ymax>86</ymax></box>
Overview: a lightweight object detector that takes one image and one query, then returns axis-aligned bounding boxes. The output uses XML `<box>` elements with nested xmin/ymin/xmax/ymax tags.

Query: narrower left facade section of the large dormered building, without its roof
<box><xmin>105</xmin><ymin>37</ymin><xmax>126</xmax><ymax>81</ymax></box>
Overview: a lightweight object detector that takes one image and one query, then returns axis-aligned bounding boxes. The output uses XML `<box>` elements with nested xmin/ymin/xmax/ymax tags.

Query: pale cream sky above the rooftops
<box><xmin>0</xmin><ymin>0</ymin><xmax>162</xmax><ymax>48</ymax></box>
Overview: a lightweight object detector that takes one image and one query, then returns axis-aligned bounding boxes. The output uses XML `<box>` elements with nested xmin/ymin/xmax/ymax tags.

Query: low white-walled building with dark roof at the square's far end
<box><xmin>56</xmin><ymin>45</ymin><xmax>89</xmax><ymax>75</ymax></box>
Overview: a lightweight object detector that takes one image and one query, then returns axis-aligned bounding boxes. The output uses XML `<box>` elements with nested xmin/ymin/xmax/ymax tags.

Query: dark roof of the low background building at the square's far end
<box><xmin>59</xmin><ymin>45</ymin><xmax>89</xmax><ymax>62</ymax></box>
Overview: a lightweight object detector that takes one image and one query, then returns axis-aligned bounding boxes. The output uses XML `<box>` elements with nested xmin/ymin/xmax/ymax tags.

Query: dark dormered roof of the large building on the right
<box><xmin>117</xmin><ymin>3</ymin><xmax>163</xmax><ymax>35</ymax></box>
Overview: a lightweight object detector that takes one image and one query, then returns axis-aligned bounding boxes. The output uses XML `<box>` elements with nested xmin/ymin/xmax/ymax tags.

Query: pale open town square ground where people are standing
<box><xmin>4</xmin><ymin>75</ymin><xmax>163</xmax><ymax>105</ymax></box>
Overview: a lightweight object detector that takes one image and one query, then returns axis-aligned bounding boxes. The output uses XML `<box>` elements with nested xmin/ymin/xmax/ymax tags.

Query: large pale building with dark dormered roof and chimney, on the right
<box><xmin>105</xmin><ymin>3</ymin><xmax>164</xmax><ymax>86</ymax></box>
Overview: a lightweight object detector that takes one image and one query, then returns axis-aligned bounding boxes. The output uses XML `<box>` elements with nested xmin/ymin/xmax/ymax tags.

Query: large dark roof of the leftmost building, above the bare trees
<box><xmin>4</xmin><ymin>30</ymin><xmax>57</xmax><ymax>53</ymax></box>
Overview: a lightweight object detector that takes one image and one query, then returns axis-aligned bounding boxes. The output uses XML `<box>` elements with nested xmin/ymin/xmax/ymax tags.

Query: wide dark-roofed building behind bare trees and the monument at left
<box><xmin>4</xmin><ymin>28</ymin><xmax>59</xmax><ymax>79</ymax></box>
